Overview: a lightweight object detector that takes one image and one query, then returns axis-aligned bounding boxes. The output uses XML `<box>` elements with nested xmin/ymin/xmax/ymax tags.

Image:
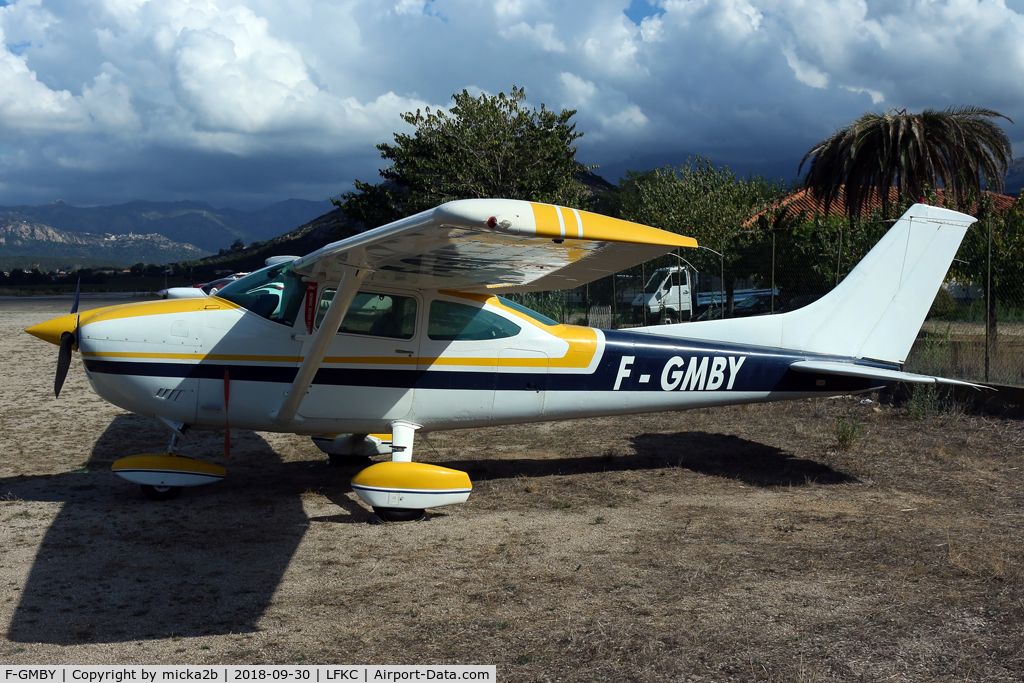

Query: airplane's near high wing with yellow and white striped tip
<box><xmin>292</xmin><ymin>199</ymin><xmax>697</xmax><ymax>292</ymax></box>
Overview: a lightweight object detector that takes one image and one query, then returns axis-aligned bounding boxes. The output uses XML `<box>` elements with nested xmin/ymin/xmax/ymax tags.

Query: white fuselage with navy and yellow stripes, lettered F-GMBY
<box><xmin>79</xmin><ymin>288</ymin><xmax>869</xmax><ymax>434</ymax></box>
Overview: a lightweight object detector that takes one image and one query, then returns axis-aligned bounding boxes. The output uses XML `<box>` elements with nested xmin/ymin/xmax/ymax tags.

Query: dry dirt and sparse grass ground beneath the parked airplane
<box><xmin>0</xmin><ymin>300</ymin><xmax>1024</xmax><ymax>681</ymax></box>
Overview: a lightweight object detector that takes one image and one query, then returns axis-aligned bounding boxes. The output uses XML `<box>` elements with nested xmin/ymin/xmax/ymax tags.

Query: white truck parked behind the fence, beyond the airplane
<box><xmin>633</xmin><ymin>265</ymin><xmax>772</xmax><ymax>325</ymax></box>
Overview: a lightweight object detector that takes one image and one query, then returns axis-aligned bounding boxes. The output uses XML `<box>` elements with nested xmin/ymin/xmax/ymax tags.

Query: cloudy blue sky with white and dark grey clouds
<box><xmin>0</xmin><ymin>0</ymin><xmax>1024</xmax><ymax>209</ymax></box>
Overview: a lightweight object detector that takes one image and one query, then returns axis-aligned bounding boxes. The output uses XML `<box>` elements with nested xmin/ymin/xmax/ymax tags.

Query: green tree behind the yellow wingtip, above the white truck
<box><xmin>616</xmin><ymin>159</ymin><xmax>783</xmax><ymax>311</ymax></box>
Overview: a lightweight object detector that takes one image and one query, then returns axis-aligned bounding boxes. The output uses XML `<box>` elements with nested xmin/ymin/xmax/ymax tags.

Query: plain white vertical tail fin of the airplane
<box><xmin>637</xmin><ymin>204</ymin><xmax>977</xmax><ymax>364</ymax></box>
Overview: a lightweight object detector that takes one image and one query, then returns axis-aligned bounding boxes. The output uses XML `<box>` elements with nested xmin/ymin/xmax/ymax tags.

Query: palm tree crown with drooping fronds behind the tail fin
<box><xmin>798</xmin><ymin>106</ymin><xmax>1013</xmax><ymax>218</ymax></box>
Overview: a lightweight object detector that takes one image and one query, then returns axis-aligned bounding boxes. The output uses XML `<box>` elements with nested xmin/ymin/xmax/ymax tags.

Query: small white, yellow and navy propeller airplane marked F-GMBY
<box><xmin>27</xmin><ymin>200</ymin><xmax>975</xmax><ymax>520</ymax></box>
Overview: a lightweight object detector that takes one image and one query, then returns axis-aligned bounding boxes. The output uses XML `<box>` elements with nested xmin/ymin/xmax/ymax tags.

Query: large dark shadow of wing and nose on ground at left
<box><xmin>0</xmin><ymin>415</ymin><xmax>370</xmax><ymax>645</ymax></box>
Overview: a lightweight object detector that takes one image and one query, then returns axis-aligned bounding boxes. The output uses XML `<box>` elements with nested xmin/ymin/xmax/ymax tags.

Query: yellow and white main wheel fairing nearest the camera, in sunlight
<box><xmin>352</xmin><ymin>462</ymin><xmax>473</xmax><ymax>511</ymax></box>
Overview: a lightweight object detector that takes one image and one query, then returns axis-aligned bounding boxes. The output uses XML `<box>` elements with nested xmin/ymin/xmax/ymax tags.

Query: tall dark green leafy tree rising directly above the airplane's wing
<box><xmin>332</xmin><ymin>86</ymin><xmax>587</xmax><ymax>227</ymax></box>
